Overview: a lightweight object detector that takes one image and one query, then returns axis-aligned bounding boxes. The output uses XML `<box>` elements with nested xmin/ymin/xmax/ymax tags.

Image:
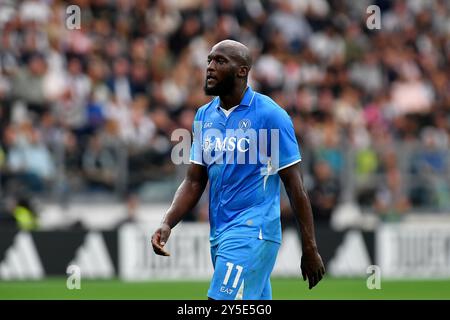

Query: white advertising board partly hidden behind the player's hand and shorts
<box><xmin>118</xmin><ymin>222</ymin><xmax>301</xmax><ymax>281</ymax></box>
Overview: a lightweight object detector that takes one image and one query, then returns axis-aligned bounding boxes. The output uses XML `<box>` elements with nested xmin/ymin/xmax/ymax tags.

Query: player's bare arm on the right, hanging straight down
<box><xmin>278</xmin><ymin>164</ymin><xmax>325</xmax><ymax>289</ymax></box>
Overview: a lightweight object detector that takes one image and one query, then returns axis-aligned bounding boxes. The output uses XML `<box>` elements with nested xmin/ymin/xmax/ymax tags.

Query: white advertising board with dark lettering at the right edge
<box><xmin>375</xmin><ymin>223</ymin><xmax>450</xmax><ymax>278</ymax></box>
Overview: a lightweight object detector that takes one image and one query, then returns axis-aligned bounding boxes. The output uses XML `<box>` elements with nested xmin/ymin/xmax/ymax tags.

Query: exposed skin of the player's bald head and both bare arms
<box><xmin>152</xmin><ymin>40</ymin><xmax>325</xmax><ymax>289</ymax></box>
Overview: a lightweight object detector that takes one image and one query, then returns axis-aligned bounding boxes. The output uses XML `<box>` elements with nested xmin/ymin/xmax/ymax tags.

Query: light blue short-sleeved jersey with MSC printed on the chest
<box><xmin>190</xmin><ymin>87</ymin><xmax>301</xmax><ymax>246</ymax></box>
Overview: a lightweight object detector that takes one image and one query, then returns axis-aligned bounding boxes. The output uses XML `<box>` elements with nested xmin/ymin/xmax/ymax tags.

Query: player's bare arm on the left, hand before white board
<box><xmin>152</xmin><ymin>163</ymin><xmax>208</xmax><ymax>256</ymax></box>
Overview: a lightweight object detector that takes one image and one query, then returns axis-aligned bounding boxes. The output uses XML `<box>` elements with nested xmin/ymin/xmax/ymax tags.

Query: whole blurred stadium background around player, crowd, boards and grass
<box><xmin>0</xmin><ymin>0</ymin><xmax>450</xmax><ymax>299</ymax></box>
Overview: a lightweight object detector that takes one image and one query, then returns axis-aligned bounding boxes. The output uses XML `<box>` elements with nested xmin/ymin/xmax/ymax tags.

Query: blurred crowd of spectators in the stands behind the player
<box><xmin>0</xmin><ymin>0</ymin><xmax>450</xmax><ymax>229</ymax></box>
